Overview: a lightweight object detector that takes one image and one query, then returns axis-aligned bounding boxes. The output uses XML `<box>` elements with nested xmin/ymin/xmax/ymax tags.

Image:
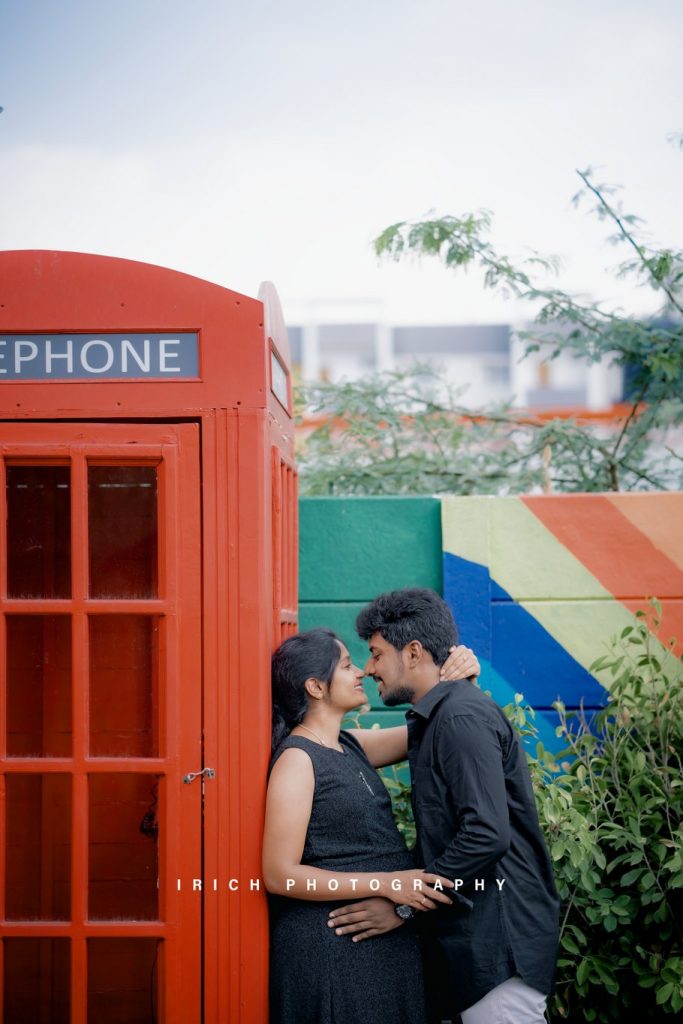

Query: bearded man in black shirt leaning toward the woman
<box><xmin>332</xmin><ymin>589</ymin><xmax>559</xmax><ymax>1024</ymax></box>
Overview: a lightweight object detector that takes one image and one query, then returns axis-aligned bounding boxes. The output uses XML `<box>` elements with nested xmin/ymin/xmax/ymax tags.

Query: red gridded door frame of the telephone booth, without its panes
<box><xmin>0</xmin><ymin>423</ymin><xmax>202</xmax><ymax>1024</ymax></box>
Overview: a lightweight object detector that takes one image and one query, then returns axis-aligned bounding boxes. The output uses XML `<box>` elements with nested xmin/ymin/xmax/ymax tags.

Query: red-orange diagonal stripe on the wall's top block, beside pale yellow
<box><xmin>521</xmin><ymin>495</ymin><xmax>683</xmax><ymax>600</ymax></box>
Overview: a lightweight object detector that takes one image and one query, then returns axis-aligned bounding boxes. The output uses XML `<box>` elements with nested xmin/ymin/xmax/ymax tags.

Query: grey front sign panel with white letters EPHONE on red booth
<box><xmin>0</xmin><ymin>332</ymin><xmax>199</xmax><ymax>381</ymax></box>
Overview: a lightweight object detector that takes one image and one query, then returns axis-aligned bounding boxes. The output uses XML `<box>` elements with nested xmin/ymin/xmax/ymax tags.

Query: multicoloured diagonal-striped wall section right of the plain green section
<box><xmin>441</xmin><ymin>494</ymin><xmax>683</xmax><ymax>750</ymax></box>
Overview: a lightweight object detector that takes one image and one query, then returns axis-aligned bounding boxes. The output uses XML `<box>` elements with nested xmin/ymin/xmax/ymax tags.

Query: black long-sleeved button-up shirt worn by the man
<box><xmin>405</xmin><ymin>680</ymin><xmax>559</xmax><ymax>1012</ymax></box>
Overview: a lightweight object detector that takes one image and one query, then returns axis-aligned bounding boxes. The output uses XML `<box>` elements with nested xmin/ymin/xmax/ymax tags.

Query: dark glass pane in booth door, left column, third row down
<box><xmin>5</xmin><ymin>772</ymin><xmax>72</xmax><ymax>921</ymax></box>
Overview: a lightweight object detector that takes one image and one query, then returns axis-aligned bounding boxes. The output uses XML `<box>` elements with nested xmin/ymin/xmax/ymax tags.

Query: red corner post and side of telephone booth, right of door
<box><xmin>202</xmin><ymin>410</ymin><xmax>297</xmax><ymax>1024</ymax></box>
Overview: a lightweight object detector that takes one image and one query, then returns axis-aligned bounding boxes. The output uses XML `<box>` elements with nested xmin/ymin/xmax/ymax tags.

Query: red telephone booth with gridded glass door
<box><xmin>0</xmin><ymin>252</ymin><xmax>297</xmax><ymax>1024</ymax></box>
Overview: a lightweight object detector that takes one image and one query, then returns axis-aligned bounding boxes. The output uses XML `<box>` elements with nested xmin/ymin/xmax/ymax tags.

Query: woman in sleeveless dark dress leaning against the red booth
<box><xmin>263</xmin><ymin>629</ymin><xmax>479</xmax><ymax>1024</ymax></box>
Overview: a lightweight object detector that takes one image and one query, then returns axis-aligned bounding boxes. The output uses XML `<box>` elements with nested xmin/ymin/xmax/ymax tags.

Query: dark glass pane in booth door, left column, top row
<box><xmin>7</xmin><ymin>464</ymin><xmax>71</xmax><ymax>598</ymax></box>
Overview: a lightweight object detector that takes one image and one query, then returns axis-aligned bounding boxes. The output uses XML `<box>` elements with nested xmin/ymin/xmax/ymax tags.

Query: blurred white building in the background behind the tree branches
<box><xmin>288</xmin><ymin>321</ymin><xmax>624</xmax><ymax>412</ymax></box>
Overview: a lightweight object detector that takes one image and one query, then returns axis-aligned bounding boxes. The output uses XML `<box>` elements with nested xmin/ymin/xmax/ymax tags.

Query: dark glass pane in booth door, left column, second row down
<box><xmin>7</xmin><ymin>615</ymin><xmax>72</xmax><ymax>758</ymax></box>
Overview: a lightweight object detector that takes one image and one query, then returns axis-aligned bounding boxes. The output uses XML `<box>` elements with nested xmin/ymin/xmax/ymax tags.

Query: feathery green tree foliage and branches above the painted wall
<box><xmin>299</xmin><ymin>171</ymin><xmax>683</xmax><ymax>495</ymax></box>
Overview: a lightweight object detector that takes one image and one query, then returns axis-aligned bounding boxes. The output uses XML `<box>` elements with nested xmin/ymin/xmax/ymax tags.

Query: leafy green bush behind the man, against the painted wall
<box><xmin>378</xmin><ymin>602</ymin><xmax>683</xmax><ymax>1022</ymax></box>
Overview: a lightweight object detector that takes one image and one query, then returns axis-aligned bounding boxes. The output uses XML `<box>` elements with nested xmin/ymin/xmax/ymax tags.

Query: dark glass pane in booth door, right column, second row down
<box><xmin>90</xmin><ymin>615</ymin><xmax>159</xmax><ymax>758</ymax></box>
